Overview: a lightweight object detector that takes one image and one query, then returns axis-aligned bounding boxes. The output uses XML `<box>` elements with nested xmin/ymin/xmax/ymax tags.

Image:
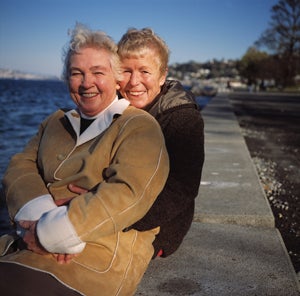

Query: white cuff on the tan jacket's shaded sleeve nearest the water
<box><xmin>14</xmin><ymin>194</ymin><xmax>57</xmax><ymax>222</ymax></box>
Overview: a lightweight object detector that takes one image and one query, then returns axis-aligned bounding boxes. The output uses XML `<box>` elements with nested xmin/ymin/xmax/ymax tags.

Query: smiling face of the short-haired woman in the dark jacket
<box><xmin>119</xmin><ymin>49</ymin><xmax>167</xmax><ymax>108</ymax></box>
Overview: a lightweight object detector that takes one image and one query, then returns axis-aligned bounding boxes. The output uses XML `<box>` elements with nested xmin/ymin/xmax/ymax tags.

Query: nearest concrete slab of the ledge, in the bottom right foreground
<box><xmin>135</xmin><ymin>222</ymin><xmax>299</xmax><ymax>296</ymax></box>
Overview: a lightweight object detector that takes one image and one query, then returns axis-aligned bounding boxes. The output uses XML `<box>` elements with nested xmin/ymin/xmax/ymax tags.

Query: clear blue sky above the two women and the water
<box><xmin>0</xmin><ymin>0</ymin><xmax>278</xmax><ymax>76</ymax></box>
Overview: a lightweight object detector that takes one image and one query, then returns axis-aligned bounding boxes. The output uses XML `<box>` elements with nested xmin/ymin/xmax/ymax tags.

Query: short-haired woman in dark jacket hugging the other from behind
<box><xmin>118</xmin><ymin>28</ymin><xmax>204</xmax><ymax>257</ymax></box>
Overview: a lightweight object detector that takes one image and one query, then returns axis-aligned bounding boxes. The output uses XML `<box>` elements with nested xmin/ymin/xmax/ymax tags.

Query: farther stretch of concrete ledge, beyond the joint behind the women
<box><xmin>195</xmin><ymin>96</ymin><xmax>275</xmax><ymax>227</ymax></box>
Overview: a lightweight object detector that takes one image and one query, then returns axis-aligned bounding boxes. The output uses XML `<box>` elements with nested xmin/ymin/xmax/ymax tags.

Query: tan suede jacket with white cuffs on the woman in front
<box><xmin>1</xmin><ymin>103</ymin><xmax>169</xmax><ymax>296</ymax></box>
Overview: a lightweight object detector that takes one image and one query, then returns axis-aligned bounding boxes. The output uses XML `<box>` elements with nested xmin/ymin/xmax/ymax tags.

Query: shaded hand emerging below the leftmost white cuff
<box><xmin>19</xmin><ymin>221</ymin><xmax>49</xmax><ymax>255</ymax></box>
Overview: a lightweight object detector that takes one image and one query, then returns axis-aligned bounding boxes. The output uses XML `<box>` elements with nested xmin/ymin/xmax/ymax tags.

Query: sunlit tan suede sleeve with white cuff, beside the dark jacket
<box><xmin>38</xmin><ymin>114</ymin><xmax>169</xmax><ymax>253</ymax></box>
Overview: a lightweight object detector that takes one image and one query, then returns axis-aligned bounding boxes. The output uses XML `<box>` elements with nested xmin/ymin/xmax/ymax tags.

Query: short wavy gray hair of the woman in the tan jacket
<box><xmin>62</xmin><ymin>23</ymin><xmax>120</xmax><ymax>82</ymax></box>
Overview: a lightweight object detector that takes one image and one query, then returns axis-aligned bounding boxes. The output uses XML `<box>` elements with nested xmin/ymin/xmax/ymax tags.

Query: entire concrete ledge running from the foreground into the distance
<box><xmin>136</xmin><ymin>95</ymin><xmax>300</xmax><ymax>296</ymax></box>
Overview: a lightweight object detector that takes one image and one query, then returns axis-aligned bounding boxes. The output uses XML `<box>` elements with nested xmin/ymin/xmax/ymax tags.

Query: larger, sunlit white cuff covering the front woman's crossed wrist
<box><xmin>37</xmin><ymin>206</ymin><xmax>85</xmax><ymax>254</ymax></box>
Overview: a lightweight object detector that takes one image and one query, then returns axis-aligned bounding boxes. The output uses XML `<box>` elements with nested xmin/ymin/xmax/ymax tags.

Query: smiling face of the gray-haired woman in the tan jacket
<box><xmin>68</xmin><ymin>47</ymin><xmax>119</xmax><ymax>117</ymax></box>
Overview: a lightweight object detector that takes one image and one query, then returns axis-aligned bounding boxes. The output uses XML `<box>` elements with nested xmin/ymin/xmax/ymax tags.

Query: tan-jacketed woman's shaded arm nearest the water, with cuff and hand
<box><xmin>3</xmin><ymin>111</ymin><xmax>78</xmax><ymax>262</ymax></box>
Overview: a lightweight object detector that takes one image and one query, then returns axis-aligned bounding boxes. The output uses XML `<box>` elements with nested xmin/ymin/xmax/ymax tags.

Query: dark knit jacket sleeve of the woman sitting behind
<box><xmin>133</xmin><ymin>108</ymin><xmax>204</xmax><ymax>230</ymax></box>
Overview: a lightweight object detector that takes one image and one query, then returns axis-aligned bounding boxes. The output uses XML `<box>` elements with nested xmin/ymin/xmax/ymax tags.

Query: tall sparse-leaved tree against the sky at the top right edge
<box><xmin>255</xmin><ymin>0</ymin><xmax>300</xmax><ymax>86</ymax></box>
